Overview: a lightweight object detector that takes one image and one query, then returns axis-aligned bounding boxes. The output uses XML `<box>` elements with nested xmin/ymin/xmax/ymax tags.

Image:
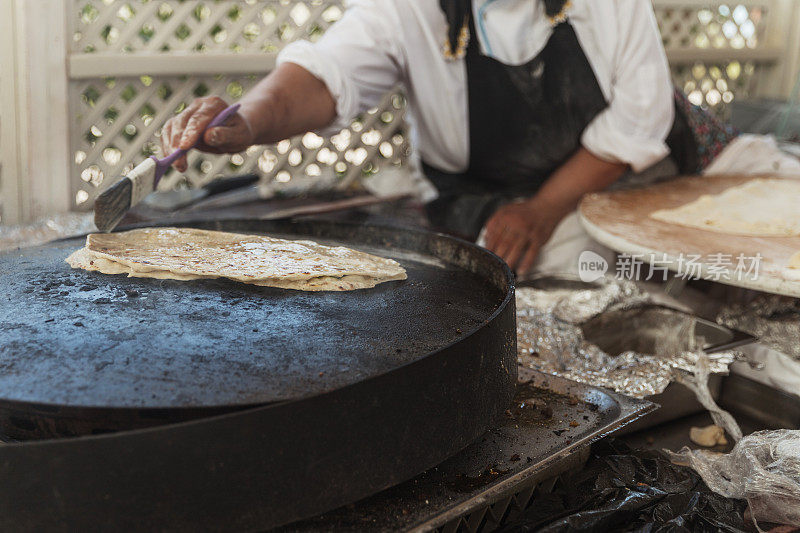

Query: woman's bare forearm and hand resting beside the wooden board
<box><xmin>485</xmin><ymin>148</ymin><xmax>628</xmax><ymax>272</ymax></box>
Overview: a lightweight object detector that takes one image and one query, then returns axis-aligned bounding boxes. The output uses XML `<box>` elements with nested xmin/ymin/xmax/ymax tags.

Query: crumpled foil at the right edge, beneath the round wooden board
<box><xmin>717</xmin><ymin>294</ymin><xmax>800</xmax><ymax>360</ymax></box>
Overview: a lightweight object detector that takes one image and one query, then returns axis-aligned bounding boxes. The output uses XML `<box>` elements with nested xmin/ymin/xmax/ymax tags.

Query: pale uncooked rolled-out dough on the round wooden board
<box><xmin>650</xmin><ymin>178</ymin><xmax>800</xmax><ymax>237</ymax></box>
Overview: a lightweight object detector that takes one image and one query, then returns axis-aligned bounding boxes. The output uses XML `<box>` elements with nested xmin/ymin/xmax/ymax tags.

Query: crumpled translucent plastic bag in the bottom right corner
<box><xmin>667</xmin><ymin>429</ymin><xmax>800</xmax><ymax>527</ymax></box>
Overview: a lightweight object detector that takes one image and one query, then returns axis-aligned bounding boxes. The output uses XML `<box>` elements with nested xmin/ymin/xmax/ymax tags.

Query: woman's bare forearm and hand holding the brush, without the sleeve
<box><xmin>161</xmin><ymin>63</ymin><xmax>336</xmax><ymax>172</ymax></box>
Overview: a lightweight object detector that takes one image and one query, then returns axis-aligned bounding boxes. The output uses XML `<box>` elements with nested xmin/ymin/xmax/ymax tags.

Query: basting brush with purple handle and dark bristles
<box><xmin>94</xmin><ymin>104</ymin><xmax>240</xmax><ymax>232</ymax></box>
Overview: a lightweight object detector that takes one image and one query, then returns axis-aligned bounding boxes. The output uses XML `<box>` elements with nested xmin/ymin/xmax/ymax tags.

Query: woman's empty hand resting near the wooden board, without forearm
<box><xmin>485</xmin><ymin>196</ymin><xmax>567</xmax><ymax>273</ymax></box>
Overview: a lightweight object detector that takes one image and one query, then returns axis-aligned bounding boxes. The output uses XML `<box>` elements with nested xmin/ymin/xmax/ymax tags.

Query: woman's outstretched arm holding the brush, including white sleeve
<box><xmin>161</xmin><ymin>0</ymin><xmax>404</xmax><ymax>172</ymax></box>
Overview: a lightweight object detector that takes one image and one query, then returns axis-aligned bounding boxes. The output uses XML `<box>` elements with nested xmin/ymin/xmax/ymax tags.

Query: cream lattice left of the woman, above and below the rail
<box><xmin>71</xmin><ymin>0</ymin><xmax>409</xmax><ymax>209</ymax></box>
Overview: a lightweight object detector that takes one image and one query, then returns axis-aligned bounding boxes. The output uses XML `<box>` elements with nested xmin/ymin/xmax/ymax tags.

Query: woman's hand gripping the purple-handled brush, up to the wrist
<box><xmin>161</xmin><ymin>96</ymin><xmax>255</xmax><ymax>172</ymax></box>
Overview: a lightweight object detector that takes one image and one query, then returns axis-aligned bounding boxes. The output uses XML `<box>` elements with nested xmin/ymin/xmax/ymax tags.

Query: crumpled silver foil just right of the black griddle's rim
<box><xmin>517</xmin><ymin>281</ymin><xmax>737</xmax><ymax>398</ymax></box>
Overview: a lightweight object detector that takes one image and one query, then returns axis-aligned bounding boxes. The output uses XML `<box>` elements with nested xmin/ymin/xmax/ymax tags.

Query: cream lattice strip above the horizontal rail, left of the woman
<box><xmin>72</xmin><ymin>0</ymin><xmax>342</xmax><ymax>54</ymax></box>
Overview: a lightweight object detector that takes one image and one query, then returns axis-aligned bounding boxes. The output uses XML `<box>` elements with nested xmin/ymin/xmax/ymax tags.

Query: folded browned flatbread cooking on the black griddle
<box><xmin>66</xmin><ymin>228</ymin><xmax>406</xmax><ymax>291</ymax></box>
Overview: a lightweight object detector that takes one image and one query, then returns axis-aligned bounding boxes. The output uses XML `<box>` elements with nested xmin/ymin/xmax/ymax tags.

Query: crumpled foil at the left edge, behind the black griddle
<box><xmin>0</xmin><ymin>213</ymin><xmax>97</xmax><ymax>250</ymax></box>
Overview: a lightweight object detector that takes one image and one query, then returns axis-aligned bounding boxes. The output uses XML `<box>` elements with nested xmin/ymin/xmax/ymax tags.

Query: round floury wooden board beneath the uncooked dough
<box><xmin>579</xmin><ymin>175</ymin><xmax>800</xmax><ymax>297</ymax></box>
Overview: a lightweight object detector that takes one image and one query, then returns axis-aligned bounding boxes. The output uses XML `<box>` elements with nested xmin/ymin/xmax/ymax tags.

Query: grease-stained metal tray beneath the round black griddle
<box><xmin>281</xmin><ymin>367</ymin><xmax>657</xmax><ymax>532</ymax></box>
